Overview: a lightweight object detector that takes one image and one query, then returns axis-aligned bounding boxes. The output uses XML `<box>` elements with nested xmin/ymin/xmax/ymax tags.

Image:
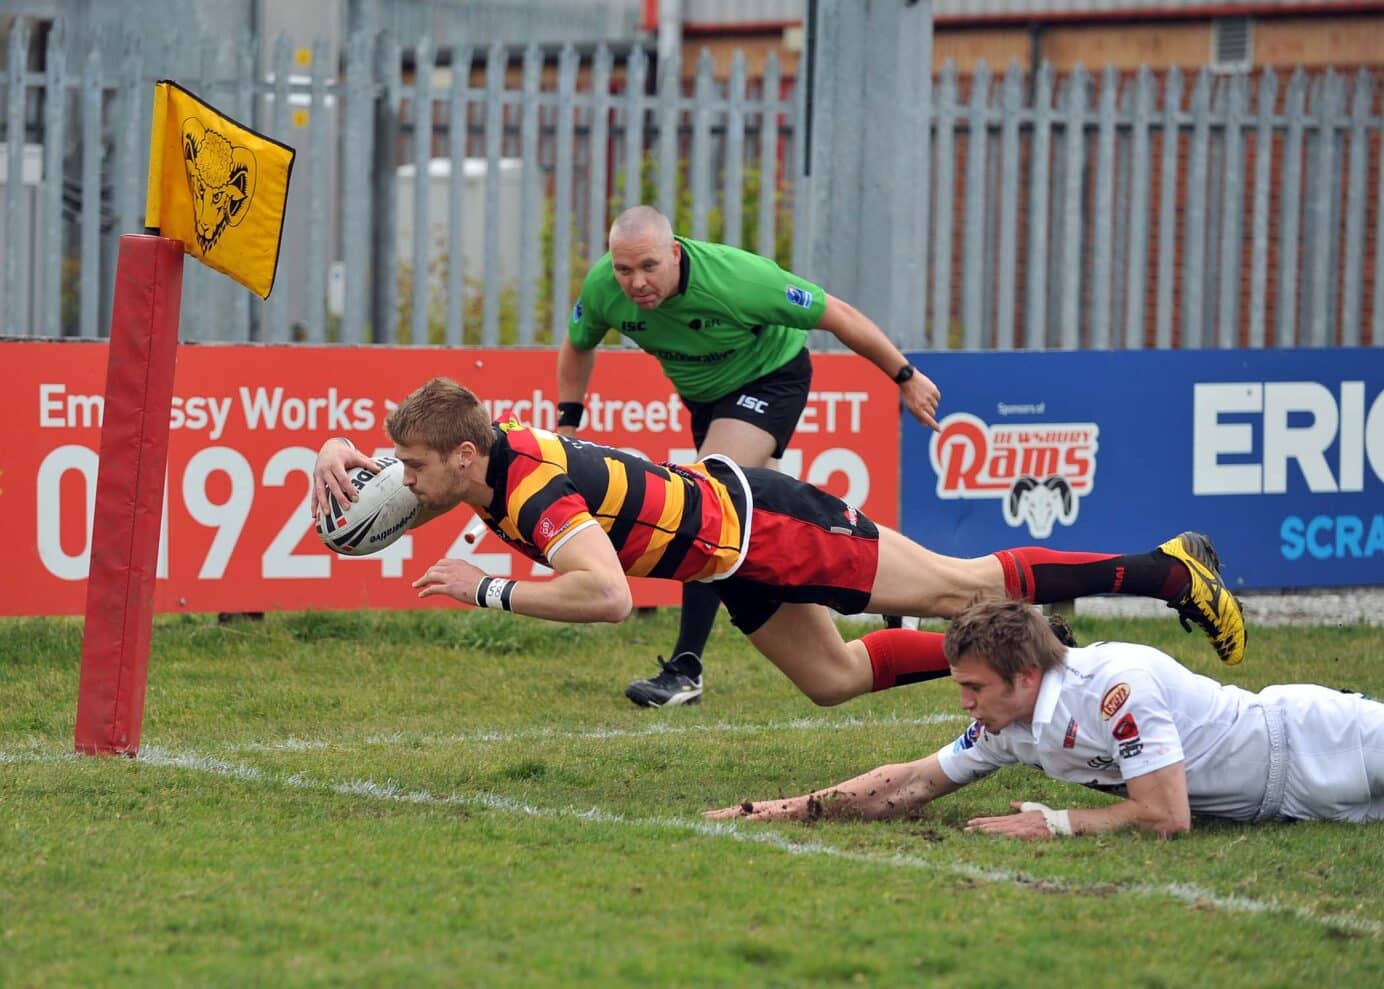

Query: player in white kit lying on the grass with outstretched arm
<box><xmin>706</xmin><ymin>599</ymin><xmax>1384</xmax><ymax>838</ymax></box>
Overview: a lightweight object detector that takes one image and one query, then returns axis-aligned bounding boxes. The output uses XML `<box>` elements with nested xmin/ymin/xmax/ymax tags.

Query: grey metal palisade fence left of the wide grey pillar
<box><xmin>0</xmin><ymin>19</ymin><xmax>801</xmax><ymax>346</ymax></box>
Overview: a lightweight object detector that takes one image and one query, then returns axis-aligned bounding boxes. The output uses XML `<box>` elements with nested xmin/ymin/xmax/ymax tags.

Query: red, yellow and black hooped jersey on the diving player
<box><xmin>480</xmin><ymin>422</ymin><xmax>747</xmax><ymax>581</ymax></box>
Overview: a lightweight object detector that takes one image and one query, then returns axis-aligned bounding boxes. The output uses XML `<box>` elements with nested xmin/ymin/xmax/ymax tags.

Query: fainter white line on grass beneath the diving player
<box><xmin>227</xmin><ymin>714</ymin><xmax>966</xmax><ymax>752</ymax></box>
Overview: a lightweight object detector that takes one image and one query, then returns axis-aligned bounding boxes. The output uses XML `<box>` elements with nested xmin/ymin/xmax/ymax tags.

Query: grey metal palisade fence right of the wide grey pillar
<box><xmin>919</xmin><ymin>64</ymin><xmax>1384</xmax><ymax>349</ymax></box>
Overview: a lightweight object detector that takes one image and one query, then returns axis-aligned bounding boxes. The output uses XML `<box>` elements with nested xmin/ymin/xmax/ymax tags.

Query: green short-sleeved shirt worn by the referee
<box><xmin>567</xmin><ymin>237</ymin><xmax>826</xmax><ymax>403</ymax></box>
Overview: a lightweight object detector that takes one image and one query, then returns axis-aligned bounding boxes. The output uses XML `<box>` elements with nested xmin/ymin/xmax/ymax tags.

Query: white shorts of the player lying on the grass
<box><xmin>1259</xmin><ymin>683</ymin><xmax>1384</xmax><ymax>822</ymax></box>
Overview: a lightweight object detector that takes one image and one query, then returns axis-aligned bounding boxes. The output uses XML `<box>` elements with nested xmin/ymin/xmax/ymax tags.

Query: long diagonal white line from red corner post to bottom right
<box><xmin>0</xmin><ymin>747</ymin><xmax>1384</xmax><ymax>936</ymax></box>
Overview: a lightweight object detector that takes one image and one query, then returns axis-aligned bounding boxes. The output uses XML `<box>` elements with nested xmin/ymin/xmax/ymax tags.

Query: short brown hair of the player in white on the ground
<box><xmin>943</xmin><ymin>596</ymin><xmax>1067</xmax><ymax>683</ymax></box>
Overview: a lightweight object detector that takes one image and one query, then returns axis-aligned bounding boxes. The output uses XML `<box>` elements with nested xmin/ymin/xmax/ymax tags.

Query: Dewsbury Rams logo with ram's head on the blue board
<box><xmin>927</xmin><ymin>412</ymin><xmax>1100</xmax><ymax>539</ymax></box>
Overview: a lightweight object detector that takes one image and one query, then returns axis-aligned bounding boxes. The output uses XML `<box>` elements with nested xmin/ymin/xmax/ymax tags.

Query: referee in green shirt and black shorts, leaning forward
<box><xmin>558</xmin><ymin>206</ymin><xmax>941</xmax><ymax>707</ymax></box>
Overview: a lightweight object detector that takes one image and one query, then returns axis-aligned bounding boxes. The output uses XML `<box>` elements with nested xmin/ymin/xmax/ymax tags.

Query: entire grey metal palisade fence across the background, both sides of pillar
<box><xmin>0</xmin><ymin>13</ymin><xmax>1384</xmax><ymax>349</ymax></box>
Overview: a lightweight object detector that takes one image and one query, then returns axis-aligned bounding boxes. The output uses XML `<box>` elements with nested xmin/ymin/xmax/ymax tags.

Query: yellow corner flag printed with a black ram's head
<box><xmin>144</xmin><ymin>80</ymin><xmax>293</xmax><ymax>299</ymax></box>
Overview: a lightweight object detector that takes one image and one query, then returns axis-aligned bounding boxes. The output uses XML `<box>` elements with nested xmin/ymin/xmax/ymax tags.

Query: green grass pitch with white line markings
<box><xmin>0</xmin><ymin>613</ymin><xmax>1384</xmax><ymax>986</ymax></box>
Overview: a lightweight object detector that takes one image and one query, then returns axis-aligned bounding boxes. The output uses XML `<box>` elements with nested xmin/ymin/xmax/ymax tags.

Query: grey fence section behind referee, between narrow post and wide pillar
<box><xmin>384</xmin><ymin>37</ymin><xmax>800</xmax><ymax>344</ymax></box>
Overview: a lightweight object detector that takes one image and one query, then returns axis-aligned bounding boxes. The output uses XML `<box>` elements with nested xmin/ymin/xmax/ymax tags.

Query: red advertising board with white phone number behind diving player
<box><xmin>0</xmin><ymin>342</ymin><xmax>900</xmax><ymax>614</ymax></box>
